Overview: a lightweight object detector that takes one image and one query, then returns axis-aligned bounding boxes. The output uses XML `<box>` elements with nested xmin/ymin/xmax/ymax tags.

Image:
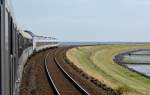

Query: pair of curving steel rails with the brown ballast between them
<box><xmin>44</xmin><ymin>49</ymin><xmax>90</xmax><ymax>95</ymax></box>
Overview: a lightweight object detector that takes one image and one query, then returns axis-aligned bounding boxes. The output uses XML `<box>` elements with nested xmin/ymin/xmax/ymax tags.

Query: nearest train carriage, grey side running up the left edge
<box><xmin>0</xmin><ymin>0</ymin><xmax>18</xmax><ymax>95</ymax></box>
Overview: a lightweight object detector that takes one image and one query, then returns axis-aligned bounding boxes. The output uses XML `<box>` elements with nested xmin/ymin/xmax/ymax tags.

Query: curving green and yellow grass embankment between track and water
<box><xmin>67</xmin><ymin>45</ymin><xmax>150</xmax><ymax>95</ymax></box>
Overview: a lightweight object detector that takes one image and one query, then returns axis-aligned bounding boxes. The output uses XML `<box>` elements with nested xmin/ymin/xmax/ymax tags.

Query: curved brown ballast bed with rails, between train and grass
<box><xmin>19</xmin><ymin>47</ymin><xmax>109</xmax><ymax>95</ymax></box>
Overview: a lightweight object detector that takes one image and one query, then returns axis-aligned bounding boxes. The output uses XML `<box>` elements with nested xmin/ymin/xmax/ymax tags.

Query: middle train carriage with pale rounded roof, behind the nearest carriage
<box><xmin>15</xmin><ymin>30</ymin><xmax>33</xmax><ymax>95</ymax></box>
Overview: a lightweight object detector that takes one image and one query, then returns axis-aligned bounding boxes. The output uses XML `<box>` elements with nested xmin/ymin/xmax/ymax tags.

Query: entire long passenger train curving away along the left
<box><xmin>0</xmin><ymin>0</ymin><xmax>59</xmax><ymax>95</ymax></box>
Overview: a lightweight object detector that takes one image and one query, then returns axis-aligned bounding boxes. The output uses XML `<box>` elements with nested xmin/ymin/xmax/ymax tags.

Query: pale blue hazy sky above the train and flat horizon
<box><xmin>12</xmin><ymin>0</ymin><xmax>150</xmax><ymax>42</ymax></box>
